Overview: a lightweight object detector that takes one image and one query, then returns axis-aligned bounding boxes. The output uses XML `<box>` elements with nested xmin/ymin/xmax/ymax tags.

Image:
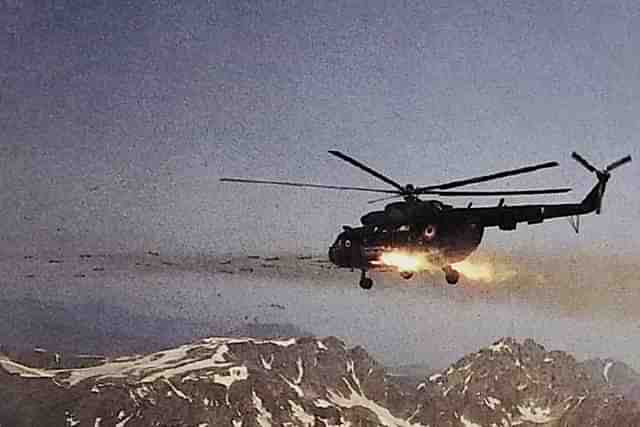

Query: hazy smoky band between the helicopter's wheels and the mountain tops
<box><xmin>0</xmin><ymin>254</ymin><xmax>640</xmax><ymax>369</ymax></box>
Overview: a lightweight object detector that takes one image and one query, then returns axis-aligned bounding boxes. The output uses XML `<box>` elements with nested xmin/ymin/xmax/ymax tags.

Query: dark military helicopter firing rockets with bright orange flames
<box><xmin>221</xmin><ymin>150</ymin><xmax>631</xmax><ymax>289</ymax></box>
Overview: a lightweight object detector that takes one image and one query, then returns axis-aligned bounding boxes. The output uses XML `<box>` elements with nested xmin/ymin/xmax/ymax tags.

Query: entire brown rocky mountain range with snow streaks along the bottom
<box><xmin>0</xmin><ymin>337</ymin><xmax>640</xmax><ymax>427</ymax></box>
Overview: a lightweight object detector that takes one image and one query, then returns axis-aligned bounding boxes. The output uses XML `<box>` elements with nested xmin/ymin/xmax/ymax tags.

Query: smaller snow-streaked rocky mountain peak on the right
<box><xmin>418</xmin><ymin>338</ymin><xmax>640</xmax><ymax>426</ymax></box>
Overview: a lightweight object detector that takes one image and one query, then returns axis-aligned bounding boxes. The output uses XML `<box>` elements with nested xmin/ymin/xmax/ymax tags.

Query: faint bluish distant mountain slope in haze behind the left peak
<box><xmin>0</xmin><ymin>298</ymin><xmax>221</xmax><ymax>355</ymax></box>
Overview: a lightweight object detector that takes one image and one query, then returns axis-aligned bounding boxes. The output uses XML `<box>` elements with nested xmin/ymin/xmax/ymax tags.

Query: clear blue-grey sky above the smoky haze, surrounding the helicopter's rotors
<box><xmin>0</xmin><ymin>0</ymin><xmax>640</xmax><ymax>254</ymax></box>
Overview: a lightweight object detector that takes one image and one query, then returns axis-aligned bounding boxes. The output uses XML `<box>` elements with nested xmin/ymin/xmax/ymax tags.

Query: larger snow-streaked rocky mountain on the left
<box><xmin>0</xmin><ymin>338</ymin><xmax>419</xmax><ymax>427</ymax></box>
